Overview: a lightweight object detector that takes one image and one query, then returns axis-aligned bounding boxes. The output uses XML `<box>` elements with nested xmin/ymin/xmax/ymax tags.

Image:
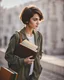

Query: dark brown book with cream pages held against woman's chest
<box><xmin>14</xmin><ymin>40</ymin><xmax>38</xmax><ymax>58</ymax></box>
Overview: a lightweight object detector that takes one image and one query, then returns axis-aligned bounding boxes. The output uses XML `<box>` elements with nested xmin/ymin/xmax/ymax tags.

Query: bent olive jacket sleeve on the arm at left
<box><xmin>5</xmin><ymin>34</ymin><xmax>24</xmax><ymax>66</ymax></box>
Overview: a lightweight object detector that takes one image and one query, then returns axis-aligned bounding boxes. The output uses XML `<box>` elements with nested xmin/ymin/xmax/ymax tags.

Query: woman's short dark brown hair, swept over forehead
<box><xmin>20</xmin><ymin>6</ymin><xmax>43</xmax><ymax>24</ymax></box>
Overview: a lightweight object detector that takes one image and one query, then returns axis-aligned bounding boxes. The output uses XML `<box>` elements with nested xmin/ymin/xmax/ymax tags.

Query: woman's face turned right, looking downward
<box><xmin>28</xmin><ymin>14</ymin><xmax>40</xmax><ymax>29</ymax></box>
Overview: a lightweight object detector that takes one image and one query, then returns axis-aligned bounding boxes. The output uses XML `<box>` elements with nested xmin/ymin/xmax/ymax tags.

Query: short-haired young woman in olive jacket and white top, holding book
<box><xmin>5</xmin><ymin>6</ymin><xmax>43</xmax><ymax>80</ymax></box>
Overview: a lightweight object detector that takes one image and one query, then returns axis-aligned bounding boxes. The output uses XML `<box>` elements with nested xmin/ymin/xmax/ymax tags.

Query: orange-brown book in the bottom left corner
<box><xmin>0</xmin><ymin>67</ymin><xmax>18</xmax><ymax>80</ymax></box>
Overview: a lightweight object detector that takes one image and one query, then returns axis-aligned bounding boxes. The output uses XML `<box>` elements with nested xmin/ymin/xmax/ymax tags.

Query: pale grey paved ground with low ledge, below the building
<box><xmin>0</xmin><ymin>50</ymin><xmax>64</xmax><ymax>80</ymax></box>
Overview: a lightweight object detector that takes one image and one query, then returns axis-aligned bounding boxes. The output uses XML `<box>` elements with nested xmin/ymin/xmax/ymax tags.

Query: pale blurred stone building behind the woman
<box><xmin>0</xmin><ymin>0</ymin><xmax>64</xmax><ymax>55</ymax></box>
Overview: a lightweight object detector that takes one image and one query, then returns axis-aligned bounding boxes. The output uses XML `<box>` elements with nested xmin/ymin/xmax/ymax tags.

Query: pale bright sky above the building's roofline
<box><xmin>1</xmin><ymin>0</ymin><xmax>35</xmax><ymax>8</ymax></box>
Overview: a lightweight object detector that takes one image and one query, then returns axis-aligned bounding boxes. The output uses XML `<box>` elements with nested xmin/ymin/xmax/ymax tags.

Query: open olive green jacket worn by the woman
<box><xmin>5</xmin><ymin>28</ymin><xmax>42</xmax><ymax>80</ymax></box>
